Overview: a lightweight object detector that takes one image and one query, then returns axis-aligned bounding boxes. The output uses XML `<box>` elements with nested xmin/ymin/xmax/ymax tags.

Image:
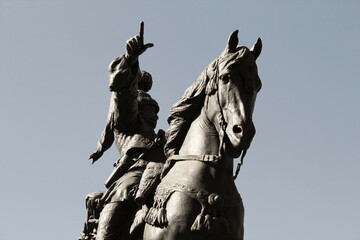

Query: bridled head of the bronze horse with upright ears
<box><xmin>206</xmin><ymin>31</ymin><xmax>262</xmax><ymax>158</ymax></box>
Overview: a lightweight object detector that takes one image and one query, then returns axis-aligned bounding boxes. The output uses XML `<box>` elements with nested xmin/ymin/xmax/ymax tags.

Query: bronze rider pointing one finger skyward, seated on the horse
<box><xmin>81</xmin><ymin>23</ymin><xmax>165</xmax><ymax>240</ymax></box>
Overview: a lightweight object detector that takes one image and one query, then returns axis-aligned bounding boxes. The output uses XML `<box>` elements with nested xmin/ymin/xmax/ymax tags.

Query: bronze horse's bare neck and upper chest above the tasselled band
<box><xmin>170</xmin><ymin>110</ymin><xmax>237</xmax><ymax>190</ymax></box>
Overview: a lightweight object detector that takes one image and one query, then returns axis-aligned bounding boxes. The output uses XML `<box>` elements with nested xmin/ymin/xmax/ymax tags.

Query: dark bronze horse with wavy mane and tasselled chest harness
<box><xmin>143</xmin><ymin>30</ymin><xmax>262</xmax><ymax>240</ymax></box>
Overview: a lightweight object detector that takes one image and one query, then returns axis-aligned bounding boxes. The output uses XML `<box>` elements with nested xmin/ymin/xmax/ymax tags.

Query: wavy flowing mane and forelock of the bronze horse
<box><xmin>164</xmin><ymin>47</ymin><xmax>250</xmax><ymax>157</ymax></box>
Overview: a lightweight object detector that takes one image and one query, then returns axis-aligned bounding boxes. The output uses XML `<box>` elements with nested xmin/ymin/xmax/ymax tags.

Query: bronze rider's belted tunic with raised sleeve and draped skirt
<box><xmin>93</xmin><ymin>56</ymin><xmax>157</xmax><ymax>204</ymax></box>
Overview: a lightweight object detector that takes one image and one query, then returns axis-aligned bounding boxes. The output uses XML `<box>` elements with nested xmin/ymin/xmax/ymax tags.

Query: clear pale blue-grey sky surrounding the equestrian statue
<box><xmin>0</xmin><ymin>0</ymin><xmax>360</xmax><ymax>240</ymax></box>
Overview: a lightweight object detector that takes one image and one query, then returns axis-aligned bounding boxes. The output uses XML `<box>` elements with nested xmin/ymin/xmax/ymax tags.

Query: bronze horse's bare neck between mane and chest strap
<box><xmin>179</xmin><ymin>109</ymin><xmax>220</xmax><ymax>155</ymax></box>
